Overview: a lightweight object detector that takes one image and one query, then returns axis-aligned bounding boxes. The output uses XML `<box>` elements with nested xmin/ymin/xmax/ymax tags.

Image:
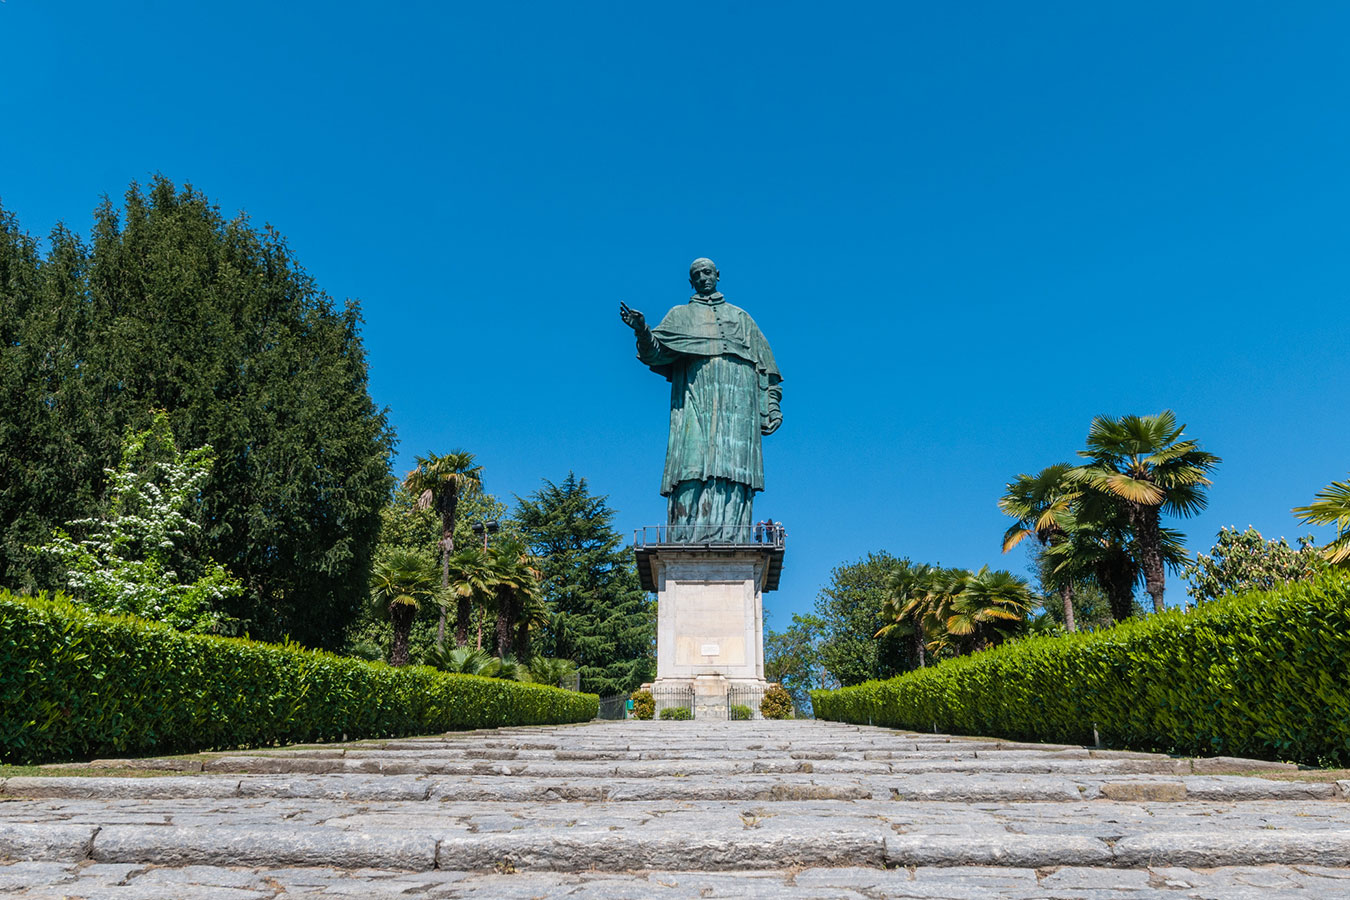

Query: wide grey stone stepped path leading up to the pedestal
<box><xmin>0</xmin><ymin>721</ymin><xmax>1350</xmax><ymax>900</ymax></box>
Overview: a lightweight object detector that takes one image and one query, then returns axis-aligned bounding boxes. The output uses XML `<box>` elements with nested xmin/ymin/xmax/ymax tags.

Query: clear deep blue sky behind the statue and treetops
<box><xmin>0</xmin><ymin>0</ymin><xmax>1350</xmax><ymax>626</ymax></box>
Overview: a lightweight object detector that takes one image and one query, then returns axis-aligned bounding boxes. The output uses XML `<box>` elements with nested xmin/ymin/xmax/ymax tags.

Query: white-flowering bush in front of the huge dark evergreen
<box><xmin>41</xmin><ymin>412</ymin><xmax>243</xmax><ymax>631</ymax></box>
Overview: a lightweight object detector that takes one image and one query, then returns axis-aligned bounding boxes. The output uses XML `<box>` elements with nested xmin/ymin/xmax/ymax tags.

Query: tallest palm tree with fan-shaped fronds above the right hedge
<box><xmin>1069</xmin><ymin>410</ymin><xmax>1222</xmax><ymax>613</ymax></box>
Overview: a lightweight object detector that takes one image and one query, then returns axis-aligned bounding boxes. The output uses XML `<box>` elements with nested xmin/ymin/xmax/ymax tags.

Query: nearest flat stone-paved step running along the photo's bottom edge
<box><xmin>0</xmin><ymin>862</ymin><xmax>1350</xmax><ymax>900</ymax></box>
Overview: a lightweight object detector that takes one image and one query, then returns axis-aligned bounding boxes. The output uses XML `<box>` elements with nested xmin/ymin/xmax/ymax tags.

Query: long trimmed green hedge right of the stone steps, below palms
<box><xmin>811</xmin><ymin>576</ymin><xmax>1350</xmax><ymax>765</ymax></box>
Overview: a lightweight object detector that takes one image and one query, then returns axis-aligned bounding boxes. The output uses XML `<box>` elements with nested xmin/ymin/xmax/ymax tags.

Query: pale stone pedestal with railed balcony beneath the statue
<box><xmin>637</xmin><ymin>544</ymin><xmax>783</xmax><ymax>719</ymax></box>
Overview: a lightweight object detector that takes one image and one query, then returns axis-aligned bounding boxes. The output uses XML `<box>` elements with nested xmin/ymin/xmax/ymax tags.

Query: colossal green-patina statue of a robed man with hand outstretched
<box><xmin>618</xmin><ymin>259</ymin><xmax>783</xmax><ymax>542</ymax></box>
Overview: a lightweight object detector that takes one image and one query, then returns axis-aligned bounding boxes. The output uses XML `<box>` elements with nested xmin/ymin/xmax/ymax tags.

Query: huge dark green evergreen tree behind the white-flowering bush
<box><xmin>0</xmin><ymin>178</ymin><xmax>393</xmax><ymax>646</ymax></box>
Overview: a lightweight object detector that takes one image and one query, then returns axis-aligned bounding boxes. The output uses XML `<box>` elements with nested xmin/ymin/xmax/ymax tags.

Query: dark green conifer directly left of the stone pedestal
<box><xmin>516</xmin><ymin>472</ymin><xmax>656</xmax><ymax>695</ymax></box>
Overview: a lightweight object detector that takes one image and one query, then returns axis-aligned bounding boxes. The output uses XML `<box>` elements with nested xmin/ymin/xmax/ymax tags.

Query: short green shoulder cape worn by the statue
<box><xmin>649</xmin><ymin>294</ymin><xmax>783</xmax><ymax>385</ymax></box>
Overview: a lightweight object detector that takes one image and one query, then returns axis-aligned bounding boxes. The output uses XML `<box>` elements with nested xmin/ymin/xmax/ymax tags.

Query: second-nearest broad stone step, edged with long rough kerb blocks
<box><xmin>0</xmin><ymin>816</ymin><xmax>1350</xmax><ymax>872</ymax></box>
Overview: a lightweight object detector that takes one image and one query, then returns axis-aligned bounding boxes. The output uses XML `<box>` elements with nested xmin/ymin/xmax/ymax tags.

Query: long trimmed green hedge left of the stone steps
<box><xmin>0</xmin><ymin>592</ymin><xmax>599</xmax><ymax>762</ymax></box>
